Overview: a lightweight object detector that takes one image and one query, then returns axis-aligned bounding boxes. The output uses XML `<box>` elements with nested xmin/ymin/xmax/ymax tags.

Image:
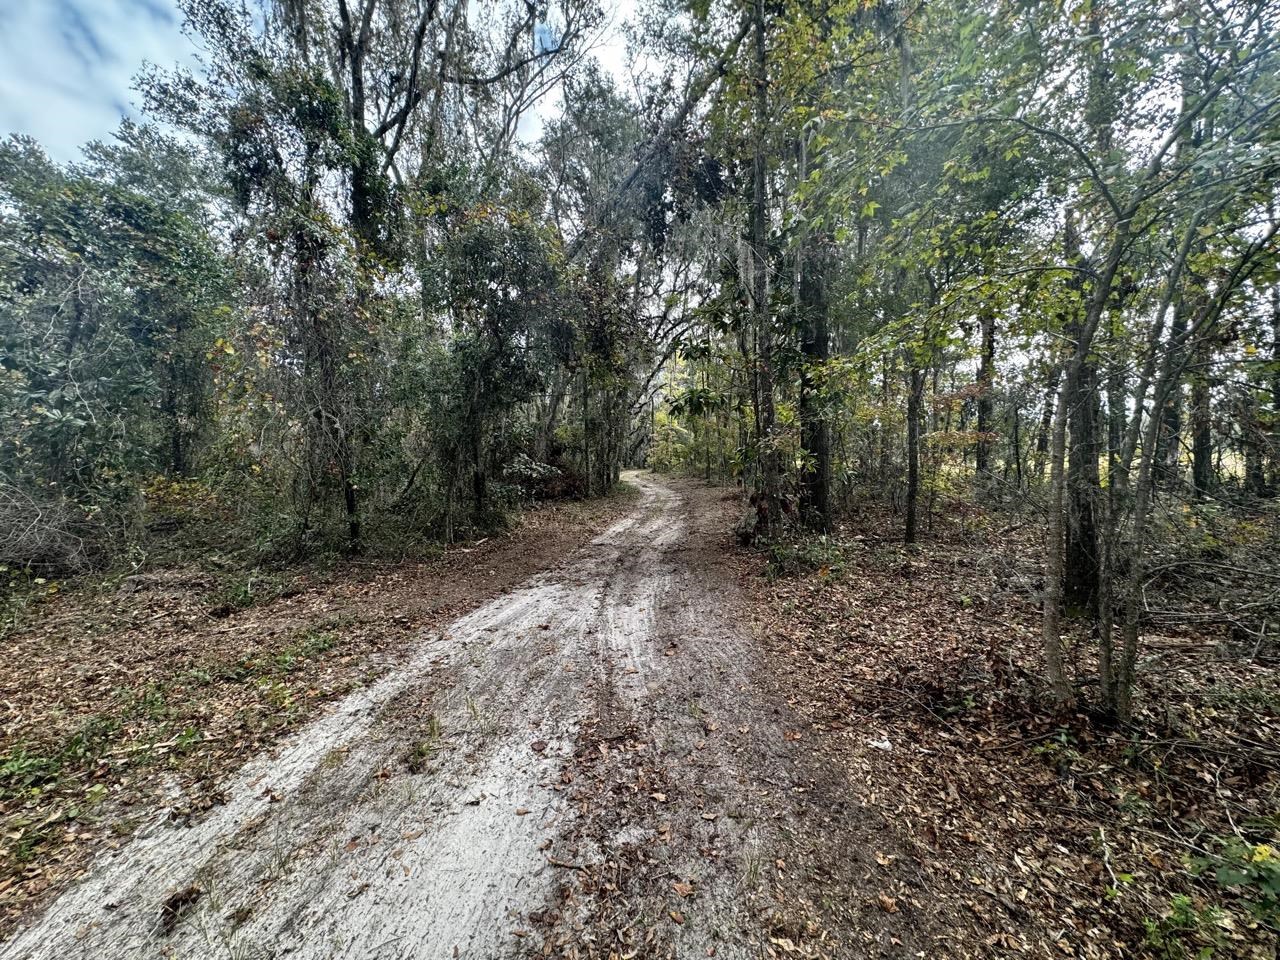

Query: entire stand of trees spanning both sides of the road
<box><xmin>0</xmin><ymin>0</ymin><xmax>1280</xmax><ymax>956</ymax></box>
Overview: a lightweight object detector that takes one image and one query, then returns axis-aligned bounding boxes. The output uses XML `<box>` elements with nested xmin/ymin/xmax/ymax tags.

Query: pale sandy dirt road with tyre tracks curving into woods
<box><xmin>0</xmin><ymin>475</ymin><xmax>909</xmax><ymax>960</ymax></box>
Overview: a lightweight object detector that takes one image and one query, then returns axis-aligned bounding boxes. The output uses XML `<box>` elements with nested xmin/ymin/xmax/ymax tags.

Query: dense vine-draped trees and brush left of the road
<box><xmin>4</xmin><ymin>3</ymin><xmax>641</xmax><ymax>564</ymax></box>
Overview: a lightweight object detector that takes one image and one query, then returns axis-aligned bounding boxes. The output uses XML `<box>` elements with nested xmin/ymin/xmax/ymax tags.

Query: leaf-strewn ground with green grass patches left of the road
<box><xmin>0</xmin><ymin>488</ymin><xmax>637</xmax><ymax>936</ymax></box>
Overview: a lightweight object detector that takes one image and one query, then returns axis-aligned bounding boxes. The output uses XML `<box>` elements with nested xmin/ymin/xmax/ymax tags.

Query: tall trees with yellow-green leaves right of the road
<box><xmin>653</xmin><ymin>4</ymin><xmax>1277</xmax><ymax>717</ymax></box>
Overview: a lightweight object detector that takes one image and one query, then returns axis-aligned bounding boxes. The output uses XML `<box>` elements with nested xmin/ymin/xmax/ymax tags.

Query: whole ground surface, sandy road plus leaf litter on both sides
<box><xmin>0</xmin><ymin>475</ymin><xmax>1280</xmax><ymax>960</ymax></box>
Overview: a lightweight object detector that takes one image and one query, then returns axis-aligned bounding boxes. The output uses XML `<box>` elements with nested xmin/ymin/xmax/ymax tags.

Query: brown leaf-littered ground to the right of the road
<box><xmin>740</xmin><ymin>504</ymin><xmax>1280</xmax><ymax>960</ymax></box>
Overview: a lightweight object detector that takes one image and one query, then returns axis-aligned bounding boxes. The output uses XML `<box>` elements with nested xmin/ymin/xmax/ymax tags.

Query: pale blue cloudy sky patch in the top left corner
<box><xmin>0</xmin><ymin>0</ymin><xmax>195</xmax><ymax>160</ymax></box>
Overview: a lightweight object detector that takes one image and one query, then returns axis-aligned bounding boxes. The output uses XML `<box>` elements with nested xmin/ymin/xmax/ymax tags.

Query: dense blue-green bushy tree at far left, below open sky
<box><xmin>0</xmin><ymin>125</ymin><xmax>225</xmax><ymax>567</ymax></box>
